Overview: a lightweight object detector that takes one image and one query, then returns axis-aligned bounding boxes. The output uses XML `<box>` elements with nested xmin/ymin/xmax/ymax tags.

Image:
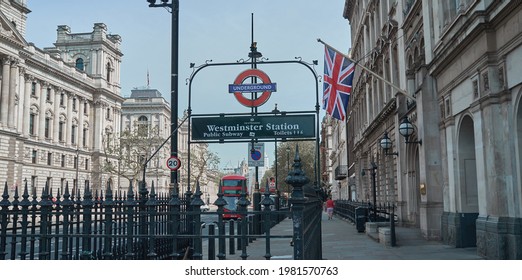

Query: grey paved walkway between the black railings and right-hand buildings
<box><xmin>227</xmin><ymin>212</ymin><xmax>483</xmax><ymax>260</ymax></box>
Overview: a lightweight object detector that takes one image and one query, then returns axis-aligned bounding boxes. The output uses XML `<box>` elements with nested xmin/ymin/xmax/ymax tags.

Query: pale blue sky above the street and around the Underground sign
<box><xmin>26</xmin><ymin>0</ymin><xmax>351</xmax><ymax>168</ymax></box>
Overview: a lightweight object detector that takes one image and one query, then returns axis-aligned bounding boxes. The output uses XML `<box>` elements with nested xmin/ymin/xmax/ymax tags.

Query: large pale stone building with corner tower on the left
<box><xmin>0</xmin><ymin>0</ymin><xmax>123</xmax><ymax>195</ymax></box>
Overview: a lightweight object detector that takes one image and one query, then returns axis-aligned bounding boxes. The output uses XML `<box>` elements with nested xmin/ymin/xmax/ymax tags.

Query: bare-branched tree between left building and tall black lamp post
<box><xmin>102</xmin><ymin>122</ymin><xmax>167</xmax><ymax>187</ymax></box>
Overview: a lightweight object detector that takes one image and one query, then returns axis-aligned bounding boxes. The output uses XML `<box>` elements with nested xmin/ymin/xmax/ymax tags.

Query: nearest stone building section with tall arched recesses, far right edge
<box><xmin>429</xmin><ymin>0</ymin><xmax>522</xmax><ymax>259</ymax></box>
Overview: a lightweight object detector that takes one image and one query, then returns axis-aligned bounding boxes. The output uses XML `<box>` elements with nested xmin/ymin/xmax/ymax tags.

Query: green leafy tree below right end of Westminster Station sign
<box><xmin>260</xmin><ymin>141</ymin><xmax>319</xmax><ymax>192</ymax></box>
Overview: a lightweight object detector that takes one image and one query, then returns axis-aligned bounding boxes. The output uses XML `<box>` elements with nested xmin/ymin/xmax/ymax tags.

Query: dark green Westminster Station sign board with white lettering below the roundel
<box><xmin>192</xmin><ymin>114</ymin><xmax>315</xmax><ymax>140</ymax></box>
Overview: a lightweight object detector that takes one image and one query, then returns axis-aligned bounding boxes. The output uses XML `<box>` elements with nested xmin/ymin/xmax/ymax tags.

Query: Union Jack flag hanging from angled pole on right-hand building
<box><xmin>323</xmin><ymin>46</ymin><xmax>355</xmax><ymax>121</ymax></box>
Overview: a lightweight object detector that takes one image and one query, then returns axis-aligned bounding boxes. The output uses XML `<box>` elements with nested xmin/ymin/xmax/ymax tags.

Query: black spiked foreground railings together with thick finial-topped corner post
<box><xmin>0</xmin><ymin>147</ymin><xmax>324</xmax><ymax>260</ymax></box>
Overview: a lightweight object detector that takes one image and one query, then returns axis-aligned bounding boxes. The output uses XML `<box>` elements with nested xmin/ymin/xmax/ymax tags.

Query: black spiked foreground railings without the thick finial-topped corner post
<box><xmin>0</xmin><ymin>179</ymin><xmax>291</xmax><ymax>260</ymax></box>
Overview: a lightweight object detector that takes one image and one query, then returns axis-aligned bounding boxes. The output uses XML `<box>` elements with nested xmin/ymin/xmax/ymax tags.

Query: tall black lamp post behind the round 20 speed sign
<box><xmin>147</xmin><ymin>0</ymin><xmax>179</xmax><ymax>193</ymax></box>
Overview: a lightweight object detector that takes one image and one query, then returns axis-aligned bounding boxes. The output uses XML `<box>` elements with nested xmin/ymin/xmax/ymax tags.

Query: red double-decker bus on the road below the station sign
<box><xmin>219</xmin><ymin>175</ymin><xmax>248</xmax><ymax>219</ymax></box>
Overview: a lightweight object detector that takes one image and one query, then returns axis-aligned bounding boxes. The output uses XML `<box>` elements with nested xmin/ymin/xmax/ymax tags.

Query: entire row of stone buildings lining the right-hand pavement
<box><xmin>338</xmin><ymin>0</ymin><xmax>522</xmax><ymax>259</ymax></box>
